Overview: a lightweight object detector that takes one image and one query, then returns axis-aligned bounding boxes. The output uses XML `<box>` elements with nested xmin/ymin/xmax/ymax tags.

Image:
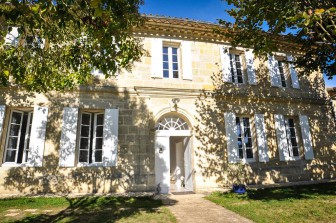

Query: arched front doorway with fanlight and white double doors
<box><xmin>155</xmin><ymin>115</ymin><xmax>193</xmax><ymax>194</ymax></box>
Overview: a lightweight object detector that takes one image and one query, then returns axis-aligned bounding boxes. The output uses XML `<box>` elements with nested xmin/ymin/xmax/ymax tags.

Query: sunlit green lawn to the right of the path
<box><xmin>207</xmin><ymin>183</ymin><xmax>336</xmax><ymax>222</ymax></box>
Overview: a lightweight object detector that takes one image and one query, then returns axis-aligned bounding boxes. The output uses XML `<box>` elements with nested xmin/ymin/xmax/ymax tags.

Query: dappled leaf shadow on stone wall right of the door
<box><xmin>195</xmin><ymin>62</ymin><xmax>336</xmax><ymax>186</ymax></box>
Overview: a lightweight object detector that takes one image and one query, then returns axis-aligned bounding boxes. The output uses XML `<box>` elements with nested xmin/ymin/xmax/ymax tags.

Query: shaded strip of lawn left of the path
<box><xmin>0</xmin><ymin>197</ymin><xmax>176</xmax><ymax>223</ymax></box>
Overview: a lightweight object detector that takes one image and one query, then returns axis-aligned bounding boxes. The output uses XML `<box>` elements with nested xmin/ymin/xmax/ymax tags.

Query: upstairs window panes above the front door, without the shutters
<box><xmin>162</xmin><ymin>46</ymin><xmax>179</xmax><ymax>78</ymax></box>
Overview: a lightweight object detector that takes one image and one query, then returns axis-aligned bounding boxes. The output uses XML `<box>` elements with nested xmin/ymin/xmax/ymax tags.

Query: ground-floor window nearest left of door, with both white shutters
<box><xmin>59</xmin><ymin>107</ymin><xmax>119</xmax><ymax>167</ymax></box>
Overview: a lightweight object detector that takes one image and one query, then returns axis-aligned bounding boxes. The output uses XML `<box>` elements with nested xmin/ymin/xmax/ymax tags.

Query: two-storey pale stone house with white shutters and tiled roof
<box><xmin>0</xmin><ymin>16</ymin><xmax>336</xmax><ymax>194</ymax></box>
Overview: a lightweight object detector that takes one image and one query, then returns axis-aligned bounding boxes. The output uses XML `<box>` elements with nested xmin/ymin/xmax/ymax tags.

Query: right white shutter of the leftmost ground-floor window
<box><xmin>27</xmin><ymin>106</ymin><xmax>48</xmax><ymax>167</ymax></box>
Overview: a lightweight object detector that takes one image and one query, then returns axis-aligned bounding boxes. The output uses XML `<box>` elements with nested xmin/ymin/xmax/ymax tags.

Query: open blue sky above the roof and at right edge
<box><xmin>140</xmin><ymin>0</ymin><xmax>336</xmax><ymax>87</ymax></box>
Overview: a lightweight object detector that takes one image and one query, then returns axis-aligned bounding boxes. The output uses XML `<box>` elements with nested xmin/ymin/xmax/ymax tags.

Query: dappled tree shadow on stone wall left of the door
<box><xmin>0</xmin><ymin>79</ymin><xmax>155</xmax><ymax>194</ymax></box>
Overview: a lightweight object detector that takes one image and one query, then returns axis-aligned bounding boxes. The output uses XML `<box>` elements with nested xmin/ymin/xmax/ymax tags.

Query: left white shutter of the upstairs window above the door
<box><xmin>151</xmin><ymin>38</ymin><xmax>163</xmax><ymax>78</ymax></box>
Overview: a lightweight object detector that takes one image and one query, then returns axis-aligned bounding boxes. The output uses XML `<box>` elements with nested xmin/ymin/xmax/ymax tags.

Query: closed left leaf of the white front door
<box><xmin>155</xmin><ymin>136</ymin><xmax>170</xmax><ymax>194</ymax></box>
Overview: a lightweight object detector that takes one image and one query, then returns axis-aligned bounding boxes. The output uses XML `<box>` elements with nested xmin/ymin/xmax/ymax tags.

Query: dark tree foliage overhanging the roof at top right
<box><xmin>219</xmin><ymin>0</ymin><xmax>336</xmax><ymax>78</ymax></box>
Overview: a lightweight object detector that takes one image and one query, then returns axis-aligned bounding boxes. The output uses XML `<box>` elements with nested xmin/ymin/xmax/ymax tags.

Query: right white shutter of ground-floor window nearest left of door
<box><xmin>103</xmin><ymin>109</ymin><xmax>119</xmax><ymax>166</ymax></box>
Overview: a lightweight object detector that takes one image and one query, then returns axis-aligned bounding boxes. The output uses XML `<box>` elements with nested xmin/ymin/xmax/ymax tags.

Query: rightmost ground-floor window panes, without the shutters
<box><xmin>285</xmin><ymin>118</ymin><xmax>299</xmax><ymax>157</ymax></box>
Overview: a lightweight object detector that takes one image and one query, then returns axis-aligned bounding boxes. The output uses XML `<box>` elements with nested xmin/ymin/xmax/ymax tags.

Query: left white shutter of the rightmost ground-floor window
<box><xmin>274</xmin><ymin>114</ymin><xmax>289</xmax><ymax>161</ymax></box>
